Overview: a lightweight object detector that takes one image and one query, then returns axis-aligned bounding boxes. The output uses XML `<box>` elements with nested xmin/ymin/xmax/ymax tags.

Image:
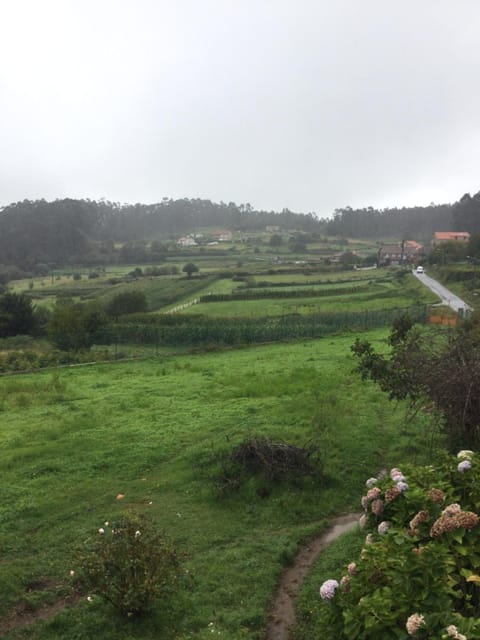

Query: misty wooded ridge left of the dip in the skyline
<box><xmin>0</xmin><ymin>199</ymin><xmax>324</xmax><ymax>269</ymax></box>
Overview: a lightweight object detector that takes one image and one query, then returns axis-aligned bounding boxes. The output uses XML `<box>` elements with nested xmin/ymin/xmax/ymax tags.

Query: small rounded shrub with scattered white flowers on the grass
<box><xmin>74</xmin><ymin>517</ymin><xmax>180</xmax><ymax>617</ymax></box>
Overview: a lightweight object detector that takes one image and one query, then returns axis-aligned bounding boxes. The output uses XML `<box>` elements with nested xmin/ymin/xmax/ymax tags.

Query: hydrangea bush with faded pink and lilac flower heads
<box><xmin>320</xmin><ymin>451</ymin><xmax>480</xmax><ymax>640</ymax></box>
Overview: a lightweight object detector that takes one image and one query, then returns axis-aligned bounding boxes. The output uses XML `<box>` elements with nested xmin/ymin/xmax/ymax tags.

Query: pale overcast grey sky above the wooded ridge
<box><xmin>0</xmin><ymin>0</ymin><xmax>480</xmax><ymax>216</ymax></box>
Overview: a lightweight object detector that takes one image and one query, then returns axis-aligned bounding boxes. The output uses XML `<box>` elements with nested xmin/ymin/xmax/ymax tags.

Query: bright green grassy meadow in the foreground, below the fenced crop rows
<box><xmin>0</xmin><ymin>332</ymin><xmax>442</xmax><ymax>640</ymax></box>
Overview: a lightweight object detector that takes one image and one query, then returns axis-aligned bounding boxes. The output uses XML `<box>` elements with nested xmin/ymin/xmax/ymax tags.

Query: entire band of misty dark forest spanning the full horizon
<box><xmin>0</xmin><ymin>192</ymin><xmax>480</xmax><ymax>271</ymax></box>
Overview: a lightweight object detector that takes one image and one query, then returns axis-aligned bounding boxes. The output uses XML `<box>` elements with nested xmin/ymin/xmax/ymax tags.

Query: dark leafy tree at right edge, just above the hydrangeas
<box><xmin>352</xmin><ymin>319</ymin><xmax>480</xmax><ymax>451</ymax></box>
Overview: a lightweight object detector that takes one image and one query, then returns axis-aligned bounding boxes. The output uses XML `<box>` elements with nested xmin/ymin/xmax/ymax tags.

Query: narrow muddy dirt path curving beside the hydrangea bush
<box><xmin>265</xmin><ymin>513</ymin><xmax>360</xmax><ymax>640</ymax></box>
